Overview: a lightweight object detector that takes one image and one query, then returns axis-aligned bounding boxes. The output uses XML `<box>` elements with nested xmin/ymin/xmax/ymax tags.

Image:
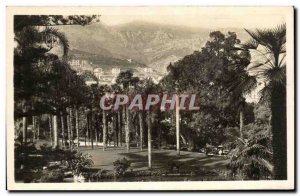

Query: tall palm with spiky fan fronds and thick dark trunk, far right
<box><xmin>243</xmin><ymin>24</ymin><xmax>287</xmax><ymax>180</ymax></box>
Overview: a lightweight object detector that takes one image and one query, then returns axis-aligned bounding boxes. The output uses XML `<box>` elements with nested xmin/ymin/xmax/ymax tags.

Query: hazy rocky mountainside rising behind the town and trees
<box><xmin>59</xmin><ymin>21</ymin><xmax>248</xmax><ymax>73</ymax></box>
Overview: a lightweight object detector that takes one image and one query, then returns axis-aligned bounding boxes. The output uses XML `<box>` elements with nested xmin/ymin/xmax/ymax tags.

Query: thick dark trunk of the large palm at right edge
<box><xmin>271</xmin><ymin>84</ymin><xmax>287</xmax><ymax>180</ymax></box>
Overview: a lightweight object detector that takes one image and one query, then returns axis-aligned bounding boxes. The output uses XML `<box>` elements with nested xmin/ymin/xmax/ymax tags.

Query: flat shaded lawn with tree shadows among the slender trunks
<box><xmin>79</xmin><ymin>147</ymin><xmax>228</xmax><ymax>170</ymax></box>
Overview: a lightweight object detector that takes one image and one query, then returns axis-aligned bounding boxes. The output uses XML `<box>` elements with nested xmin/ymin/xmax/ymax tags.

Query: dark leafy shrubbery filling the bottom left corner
<box><xmin>15</xmin><ymin>144</ymin><xmax>93</xmax><ymax>182</ymax></box>
